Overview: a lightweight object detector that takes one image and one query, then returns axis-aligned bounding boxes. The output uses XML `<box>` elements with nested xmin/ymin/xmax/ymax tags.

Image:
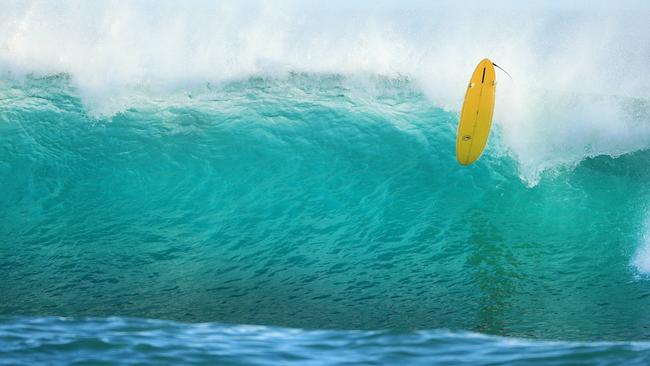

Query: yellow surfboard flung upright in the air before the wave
<box><xmin>456</xmin><ymin>59</ymin><xmax>497</xmax><ymax>165</ymax></box>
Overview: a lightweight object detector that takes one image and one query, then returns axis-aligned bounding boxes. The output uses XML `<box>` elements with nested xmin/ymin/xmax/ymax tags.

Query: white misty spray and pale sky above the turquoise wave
<box><xmin>0</xmin><ymin>0</ymin><xmax>650</xmax><ymax>184</ymax></box>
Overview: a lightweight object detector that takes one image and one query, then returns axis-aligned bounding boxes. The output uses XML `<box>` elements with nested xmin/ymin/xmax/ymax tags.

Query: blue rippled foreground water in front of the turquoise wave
<box><xmin>0</xmin><ymin>317</ymin><xmax>650</xmax><ymax>365</ymax></box>
